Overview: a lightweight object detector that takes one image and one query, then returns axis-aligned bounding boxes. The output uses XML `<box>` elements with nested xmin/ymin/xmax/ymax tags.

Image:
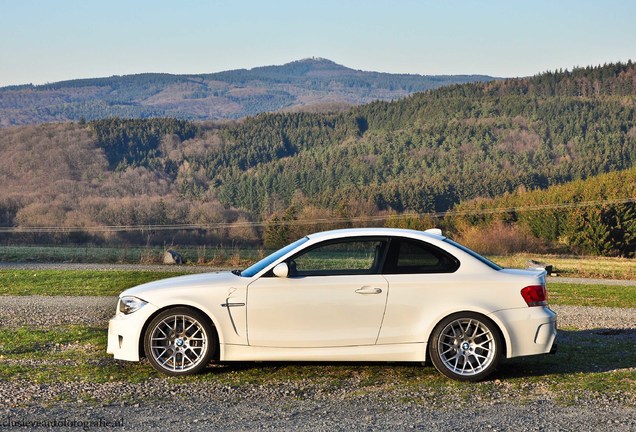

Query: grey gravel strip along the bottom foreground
<box><xmin>0</xmin><ymin>392</ymin><xmax>636</xmax><ymax>432</ymax></box>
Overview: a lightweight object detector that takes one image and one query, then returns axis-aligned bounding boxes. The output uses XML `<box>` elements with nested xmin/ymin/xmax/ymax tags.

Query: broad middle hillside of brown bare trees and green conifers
<box><xmin>0</xmin><ymin>62</ymin><xmax>636</xmax><ymax>251</ymax></box>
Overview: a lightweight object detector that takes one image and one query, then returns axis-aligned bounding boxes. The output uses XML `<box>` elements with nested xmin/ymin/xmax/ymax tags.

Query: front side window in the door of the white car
<box><xmin>288</xmin><ymin>239</ymin><xmax>387</xmax><ymax>277</ymax></box>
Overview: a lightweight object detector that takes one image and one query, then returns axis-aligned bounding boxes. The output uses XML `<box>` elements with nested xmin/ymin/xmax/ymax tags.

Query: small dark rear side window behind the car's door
<box><xmin>385</xmin><ymin>239</ymin><xmax>459</xmax><ymax>274</ymax></box>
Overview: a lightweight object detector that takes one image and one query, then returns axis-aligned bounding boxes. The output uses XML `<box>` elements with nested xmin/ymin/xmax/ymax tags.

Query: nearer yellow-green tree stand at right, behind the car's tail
<box><xmin>449</xmin><ymin>167</ymin><xmax>636</xmax><ymax>258</ymax></box>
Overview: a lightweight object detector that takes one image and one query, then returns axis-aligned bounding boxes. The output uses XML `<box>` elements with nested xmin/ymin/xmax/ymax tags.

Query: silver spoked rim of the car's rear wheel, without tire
<box><xmin>437</xmin><ymin>318</ymin><xmax>498</xmax><ymax>377</ymax></box>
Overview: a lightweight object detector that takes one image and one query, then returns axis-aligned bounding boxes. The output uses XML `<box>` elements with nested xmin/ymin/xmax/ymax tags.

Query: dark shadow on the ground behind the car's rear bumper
<box><xmin>491</xmin><ymin>328</ymin><xmax>636</xmax><ymax>379</ymax></box>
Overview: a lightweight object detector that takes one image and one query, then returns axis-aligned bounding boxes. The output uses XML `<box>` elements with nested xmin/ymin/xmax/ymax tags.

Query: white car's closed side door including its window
<box><xmin>247</xmin><ymin>238</ymin><xmax>388</xmax><ymax>348</ymax></box>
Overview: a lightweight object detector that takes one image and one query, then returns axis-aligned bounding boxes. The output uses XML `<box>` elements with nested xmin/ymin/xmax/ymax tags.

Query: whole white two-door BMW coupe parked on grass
<box><xmin>108</xmin><ymin>228</ymin><xmax>556</xmax><ymax>381</ymax></box>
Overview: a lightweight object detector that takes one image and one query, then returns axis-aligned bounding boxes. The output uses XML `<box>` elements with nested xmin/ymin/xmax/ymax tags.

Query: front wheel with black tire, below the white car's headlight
<box><xmin>144</xmin><ymin>307</ymin><xmax>217</xmax><ymax>376</ymax></box>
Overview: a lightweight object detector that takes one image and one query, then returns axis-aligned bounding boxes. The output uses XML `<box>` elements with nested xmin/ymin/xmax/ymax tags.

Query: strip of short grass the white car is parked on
<box><xmin>0</xmin><ymin>325</ymin><xmax>636</xmax><ymax>408</ymax></box>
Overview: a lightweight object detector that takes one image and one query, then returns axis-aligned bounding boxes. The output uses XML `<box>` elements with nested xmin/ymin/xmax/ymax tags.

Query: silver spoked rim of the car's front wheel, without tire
<box><xmin>149</xmin><ymin>314</ymin><xmax>209</xmax><ymax>373</ymax></box>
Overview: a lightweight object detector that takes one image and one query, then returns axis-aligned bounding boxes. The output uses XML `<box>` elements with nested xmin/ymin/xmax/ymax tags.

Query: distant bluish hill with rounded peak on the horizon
<box><xmin>0</xmin><ymin>59</ymin><xmax>493</xmax><ymax>126</ymax></box>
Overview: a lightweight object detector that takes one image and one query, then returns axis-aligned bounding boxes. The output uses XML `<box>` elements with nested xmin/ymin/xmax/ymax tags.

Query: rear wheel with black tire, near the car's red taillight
<box><xmin>429</xmin><ymin>312</ymin><xmax>502</xmax><ymax>381</ymax></box>
